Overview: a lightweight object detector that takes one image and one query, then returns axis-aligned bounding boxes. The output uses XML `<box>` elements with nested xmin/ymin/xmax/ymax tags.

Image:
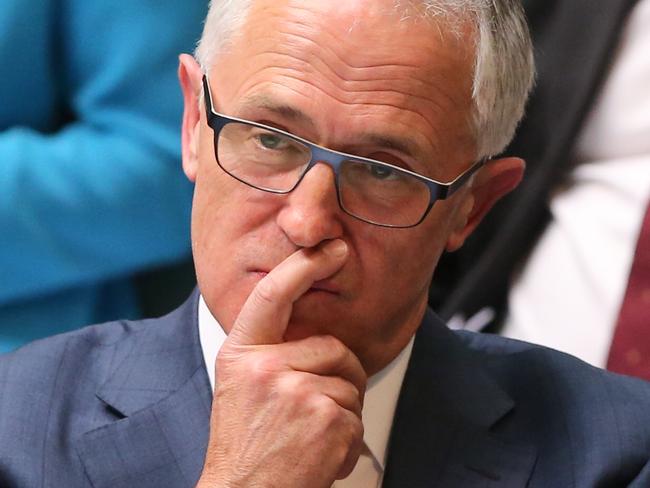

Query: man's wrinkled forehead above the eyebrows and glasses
<box><xmin>213</xmin><ymin>0</ymin><xmax>474</xmax><ymax>173</ymax></box>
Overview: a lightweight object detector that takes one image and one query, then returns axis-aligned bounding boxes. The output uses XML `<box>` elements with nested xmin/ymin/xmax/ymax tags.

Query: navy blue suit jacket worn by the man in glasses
<box><xmin>0</xmin><ymin>293</ymin><xmax>650</xmax><ymax>488</ymax></box>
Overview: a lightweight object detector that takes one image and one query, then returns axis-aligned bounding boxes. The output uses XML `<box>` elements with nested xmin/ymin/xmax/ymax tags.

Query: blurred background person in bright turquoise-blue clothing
<box><xmin>0</xmin><ymin>0</ymin><xmax>207</xmax><ymax>352</ymax></box>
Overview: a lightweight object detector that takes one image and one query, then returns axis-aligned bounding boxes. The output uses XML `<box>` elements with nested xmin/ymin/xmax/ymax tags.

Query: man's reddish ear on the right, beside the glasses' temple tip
<box><xmin>446</xmin><ymin>158</ymin><xmax>526</xmax><ymax>252</ymax></box>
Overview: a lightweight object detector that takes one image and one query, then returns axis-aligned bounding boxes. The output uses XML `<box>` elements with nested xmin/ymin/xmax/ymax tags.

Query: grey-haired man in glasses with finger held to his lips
<box><xmin>0</xmin><ymin>0</ymin><xmax>650</xmax><ymax>487</ymax></box>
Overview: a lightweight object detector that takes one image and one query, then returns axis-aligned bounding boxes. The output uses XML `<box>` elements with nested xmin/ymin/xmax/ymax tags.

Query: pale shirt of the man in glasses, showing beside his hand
<box><xmin>199</xmin><ymin>297</ymin><xmax>413</xmax><ymax>488</ymax></box>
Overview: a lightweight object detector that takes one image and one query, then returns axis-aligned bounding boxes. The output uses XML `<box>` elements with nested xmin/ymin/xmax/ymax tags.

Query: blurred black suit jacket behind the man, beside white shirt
<box><xmin>430</xmin><ymin>0</ymin><xmax>638</xmax><ymax>330</ymax></box>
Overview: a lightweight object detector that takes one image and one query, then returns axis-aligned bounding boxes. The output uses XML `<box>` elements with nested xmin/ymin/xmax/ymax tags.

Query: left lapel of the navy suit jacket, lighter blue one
<box><xmin>76</xmin><ymin>292</ymin><xmax>212</xmax><ymax>488</ymax></box>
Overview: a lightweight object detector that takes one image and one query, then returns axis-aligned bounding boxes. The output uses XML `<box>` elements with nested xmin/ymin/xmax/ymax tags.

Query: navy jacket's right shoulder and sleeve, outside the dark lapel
<box><xmin>456</xmin><ymin>332</ymin><xmax>650</xmax><ymax>486</ymax></box>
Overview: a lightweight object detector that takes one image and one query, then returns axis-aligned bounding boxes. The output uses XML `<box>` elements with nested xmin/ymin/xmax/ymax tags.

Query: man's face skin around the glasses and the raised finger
<box><xmin>184</xmin><ymin>0</ymin><xmax>475</xmax><ymax>373</ymax></box>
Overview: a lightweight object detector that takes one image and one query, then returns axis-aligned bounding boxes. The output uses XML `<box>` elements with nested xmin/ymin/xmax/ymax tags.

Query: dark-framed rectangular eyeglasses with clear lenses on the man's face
<box><xmin>203</xmin><ymin>76</ymin><xmax>485</xmax><ymax>228</ymax></box>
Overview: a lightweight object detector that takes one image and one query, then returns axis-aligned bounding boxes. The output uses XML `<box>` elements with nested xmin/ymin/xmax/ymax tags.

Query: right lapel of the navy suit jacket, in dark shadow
<box><xmin>383</xmin><ymin>311</ymin><xmax>535</xmax><ymax>488</ymax></box>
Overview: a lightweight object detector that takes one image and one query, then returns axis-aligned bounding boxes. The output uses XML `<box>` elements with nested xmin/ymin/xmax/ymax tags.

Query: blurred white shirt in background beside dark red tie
<box><xmin>503</xmin><ymin>0</ymin><xmax>650</xmax><ymax>367</ymax></box>
